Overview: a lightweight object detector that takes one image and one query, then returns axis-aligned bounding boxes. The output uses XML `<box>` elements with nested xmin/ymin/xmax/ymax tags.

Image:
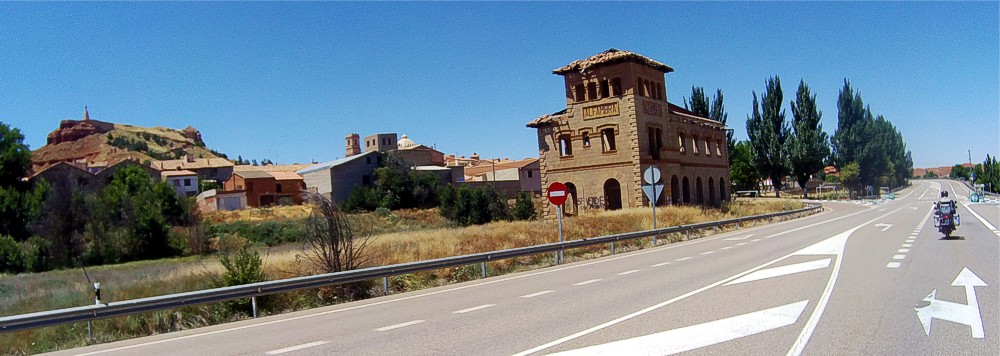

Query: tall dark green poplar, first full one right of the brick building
<box><xmin>747</xmin><ymin>76</ymin><xmax>790</xmax><ymax>197</ymax></box>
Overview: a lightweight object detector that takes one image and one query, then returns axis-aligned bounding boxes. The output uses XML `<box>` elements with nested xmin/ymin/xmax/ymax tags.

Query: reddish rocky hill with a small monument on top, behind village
<box><xmin>31</xmin><ymin>112</ymin><xmax>226</xmax><ymax>172</ymax></box>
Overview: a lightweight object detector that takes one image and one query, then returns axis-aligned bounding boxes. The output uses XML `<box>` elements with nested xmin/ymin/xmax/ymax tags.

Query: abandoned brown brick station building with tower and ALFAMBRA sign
<box><xmin>527</xmin><ymin>49</ymin><xmax>729</xmax><ymax>216</ymax></box>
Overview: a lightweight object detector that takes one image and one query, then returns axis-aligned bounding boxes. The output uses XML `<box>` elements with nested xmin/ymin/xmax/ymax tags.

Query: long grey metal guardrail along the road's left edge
<box><xmin>0</xmin><ymin>203</ymin><xmax>822</xmax><ymax>333</ymax></box>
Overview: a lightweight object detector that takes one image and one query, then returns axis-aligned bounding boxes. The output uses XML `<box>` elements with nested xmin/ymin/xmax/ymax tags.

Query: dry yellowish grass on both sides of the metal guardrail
<box><xmin>0</xmin><ymin>198</ymin><xmax>802</xmax><ymax>354</ymax></box>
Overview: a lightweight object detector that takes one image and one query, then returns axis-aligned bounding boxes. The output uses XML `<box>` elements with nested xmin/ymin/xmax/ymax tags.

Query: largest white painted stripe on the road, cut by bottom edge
<box><xmin>555</xmin><ymin>300</ymin><xmax>809</xmax><ymax>355</ymax></box>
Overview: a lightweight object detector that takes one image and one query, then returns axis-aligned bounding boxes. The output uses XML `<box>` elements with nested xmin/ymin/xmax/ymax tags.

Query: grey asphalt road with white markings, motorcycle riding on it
<box><xmin>45</xmin><ymin>181</ymin><xmax>1000</xmax><ymax>355</ymax></box>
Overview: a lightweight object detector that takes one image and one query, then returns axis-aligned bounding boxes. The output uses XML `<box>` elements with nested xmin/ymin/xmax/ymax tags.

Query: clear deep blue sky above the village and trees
<box><xmin>0</xmin><ymin>2</ymin><xmax>1000</xmax><ymax>167</ymax></box>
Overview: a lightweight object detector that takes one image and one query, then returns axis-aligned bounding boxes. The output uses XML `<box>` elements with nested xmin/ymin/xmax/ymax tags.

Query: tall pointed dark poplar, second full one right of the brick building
<box><xmin>786</xmin><ymin>81</ymin><xmax>830</xmax><ymax>198</ymax></box>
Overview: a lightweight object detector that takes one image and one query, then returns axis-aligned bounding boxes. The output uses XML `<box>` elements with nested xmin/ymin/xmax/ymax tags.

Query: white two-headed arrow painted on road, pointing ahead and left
<box><xmin>913</xmin><ymin>267</ymin><xmax>986</xmax><ymax>339</ymax></box>
